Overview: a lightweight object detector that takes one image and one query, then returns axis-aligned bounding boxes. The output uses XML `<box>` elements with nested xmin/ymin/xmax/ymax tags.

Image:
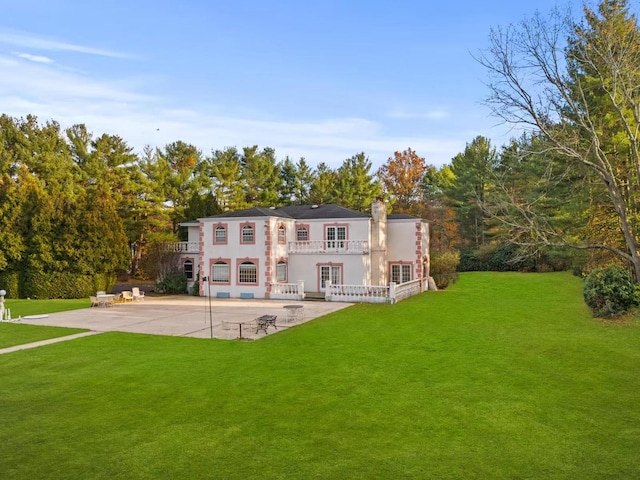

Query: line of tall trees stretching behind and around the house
<box><xmin>0</xmin><ymin>0</ymin><xmax>640</xmax><ymax>296</ymax></box>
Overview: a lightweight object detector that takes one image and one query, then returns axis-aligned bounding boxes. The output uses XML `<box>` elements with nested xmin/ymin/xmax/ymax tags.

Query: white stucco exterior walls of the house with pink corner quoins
<box><xmin>175</xmin><ymin>201</ymin><xmax>429</xmax><ymax>298</ymax></box>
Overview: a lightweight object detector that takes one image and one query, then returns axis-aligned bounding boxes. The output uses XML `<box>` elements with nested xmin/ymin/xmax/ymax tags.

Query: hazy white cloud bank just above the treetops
<box><xmin>0</xmin><ymin>44</ymin><xmax>468</xmax><ymax>170</ymax></box>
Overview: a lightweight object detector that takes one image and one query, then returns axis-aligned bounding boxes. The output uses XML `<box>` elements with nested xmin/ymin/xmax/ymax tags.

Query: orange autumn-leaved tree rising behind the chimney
<box><xmin>378</xmin><ymin>148</ymin><xmax>428</xmax><ymax>215</ymax></box>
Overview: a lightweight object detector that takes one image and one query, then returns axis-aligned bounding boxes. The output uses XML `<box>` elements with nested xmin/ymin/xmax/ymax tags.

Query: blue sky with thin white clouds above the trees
<box><xmin>0</xmin><ymin>0</ymin><xmax>580</xmax><ymax>169</ymax></box>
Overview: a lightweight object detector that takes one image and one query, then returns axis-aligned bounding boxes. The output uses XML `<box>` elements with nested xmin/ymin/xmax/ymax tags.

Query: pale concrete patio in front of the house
<box><xmin>21</xmin><ymin>296</ymin><xmax>352</xmax><ymax>340</ymax></box>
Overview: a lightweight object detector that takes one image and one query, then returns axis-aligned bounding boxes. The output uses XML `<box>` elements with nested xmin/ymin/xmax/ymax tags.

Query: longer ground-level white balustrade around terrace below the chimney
<box><xmin>325</xmin><ymin>278</ymin><xmax>427</xmax><ymax>303</ymax></box>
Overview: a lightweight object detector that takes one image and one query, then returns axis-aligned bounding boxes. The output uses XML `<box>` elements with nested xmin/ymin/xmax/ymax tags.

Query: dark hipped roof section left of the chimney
<box><xmin>200</xmin><ymin>204</ymin><xmax>371</xmax><ymax>220</ymax></box>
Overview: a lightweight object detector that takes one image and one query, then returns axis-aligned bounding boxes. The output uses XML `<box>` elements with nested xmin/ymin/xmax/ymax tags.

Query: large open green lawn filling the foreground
<box><xmin>0</xmin><ymin>273</ymin><xmax>640</xmax><ymax>479</ymax></box>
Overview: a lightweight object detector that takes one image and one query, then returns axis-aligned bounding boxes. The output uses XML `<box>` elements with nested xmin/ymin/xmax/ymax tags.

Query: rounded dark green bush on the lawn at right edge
<box><xmin>583</xmin><ymin>264</ymin><xmax>640</xmax><ymax>317</ymax></box>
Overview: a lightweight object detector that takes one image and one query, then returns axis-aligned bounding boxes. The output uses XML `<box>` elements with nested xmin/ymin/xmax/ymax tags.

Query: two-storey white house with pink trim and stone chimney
<box><xmin>171</xmin><ymin>200</ymin><xmax>429</xmax><ymax>301</ymax></box>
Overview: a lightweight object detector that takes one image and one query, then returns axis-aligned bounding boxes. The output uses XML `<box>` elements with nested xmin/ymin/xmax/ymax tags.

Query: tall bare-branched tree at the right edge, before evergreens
<box><xmin>479</xmin><ymin>0</ymin><xmax>640</xmax><ymax>281</ymax></box>
